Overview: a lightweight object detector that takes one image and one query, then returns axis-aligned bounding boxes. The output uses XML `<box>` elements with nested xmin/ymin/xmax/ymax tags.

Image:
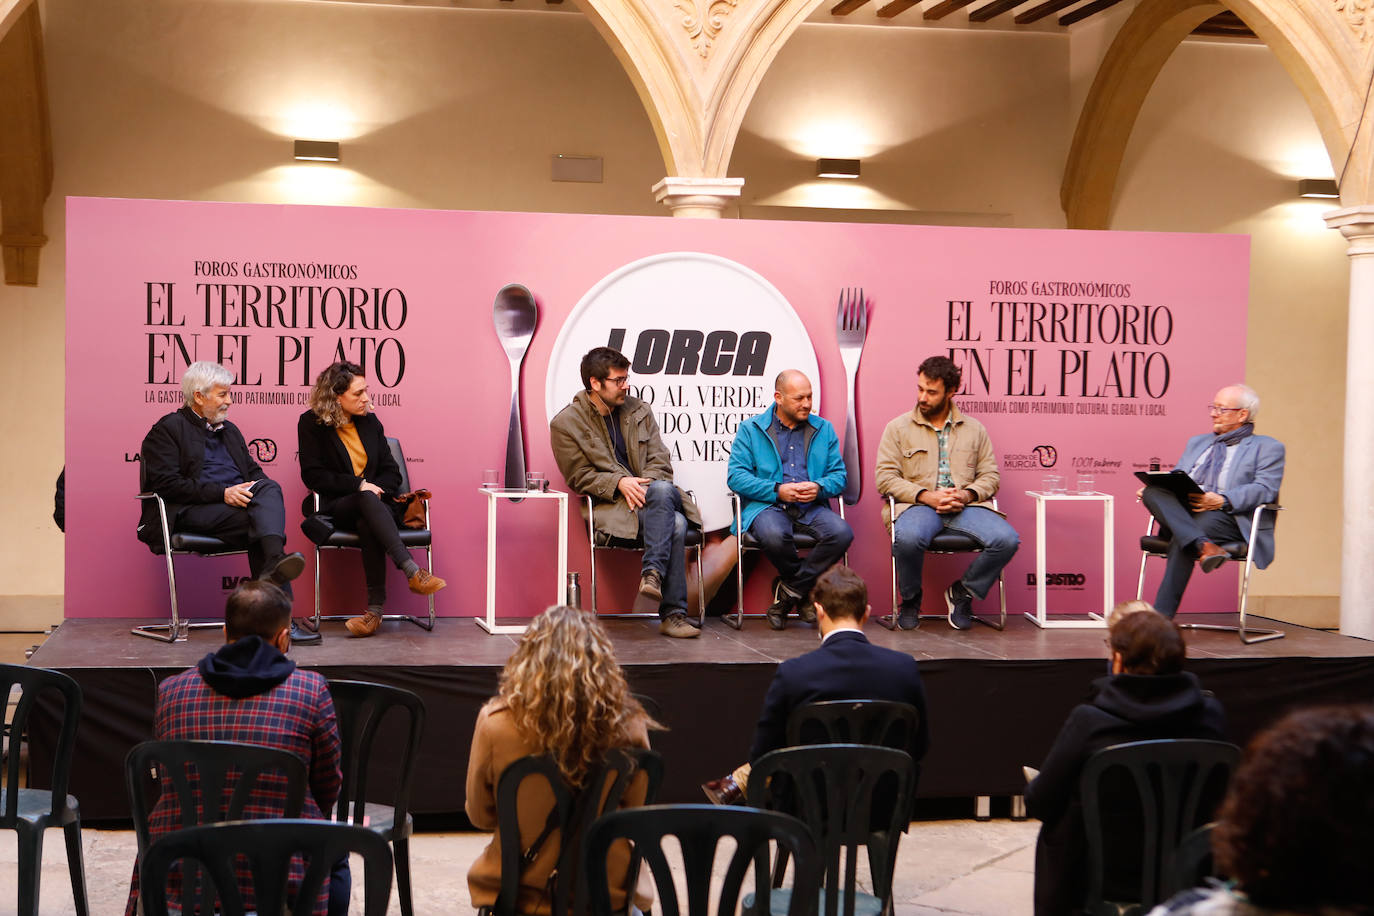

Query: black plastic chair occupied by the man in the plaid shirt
<box><xmin>124</xmin><ymin>742</ymin><xmax>306</xmax><ymax>898</ymax></box>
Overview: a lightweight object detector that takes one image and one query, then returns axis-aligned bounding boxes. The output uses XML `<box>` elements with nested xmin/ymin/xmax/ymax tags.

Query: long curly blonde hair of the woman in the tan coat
<box><xmin>497</xmin><ymin>606</ymin><xmax>661</xmax><ymax>786</ymax></box>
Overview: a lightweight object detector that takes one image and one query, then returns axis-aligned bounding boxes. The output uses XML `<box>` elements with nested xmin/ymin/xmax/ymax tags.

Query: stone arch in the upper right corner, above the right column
<box><xmin>1059</xmin><ymin>0</ymin><xmax>1374</xmax><ymax>229</ymax></box>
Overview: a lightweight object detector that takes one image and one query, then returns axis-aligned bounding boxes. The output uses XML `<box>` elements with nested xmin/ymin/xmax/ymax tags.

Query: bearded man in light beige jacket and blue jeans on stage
<box><xmin>877</xmin><ymin>356</ymin><xmax>1021</xmax><ymax>630</ymax></box>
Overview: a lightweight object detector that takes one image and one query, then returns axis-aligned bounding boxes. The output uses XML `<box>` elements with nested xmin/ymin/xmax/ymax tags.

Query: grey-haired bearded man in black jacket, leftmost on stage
<box><xmin>139</xmin><ymin>363</ymin><xmax>311</xmax><ymax>643</ymax></box>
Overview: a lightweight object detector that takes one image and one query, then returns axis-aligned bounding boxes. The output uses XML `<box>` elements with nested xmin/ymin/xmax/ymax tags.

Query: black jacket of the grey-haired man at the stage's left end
<box><xmin>139</xmin><ymin>407</ymin><xmax>267</xmax><ymax>548</ymax></box>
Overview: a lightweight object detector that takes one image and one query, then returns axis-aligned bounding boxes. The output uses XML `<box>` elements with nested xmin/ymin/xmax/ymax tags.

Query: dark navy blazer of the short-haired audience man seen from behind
<box><xmin>749</xmin><ymin>630</ymin><xmax>930</xmax><ymax>762</ymax></box>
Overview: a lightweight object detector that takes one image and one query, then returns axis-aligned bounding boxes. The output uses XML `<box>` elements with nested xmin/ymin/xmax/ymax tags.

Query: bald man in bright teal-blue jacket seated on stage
<box><xmin>727</xmin><ymin>369</ymin><xmax>855</xmax><ymax>630</ymax></box>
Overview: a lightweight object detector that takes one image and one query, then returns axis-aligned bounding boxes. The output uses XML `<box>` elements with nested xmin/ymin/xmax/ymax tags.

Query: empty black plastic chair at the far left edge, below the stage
<box><xmin>0</xmin><ymin>665</ymin><xmax>89</xmax><ymax>916</ymax></box>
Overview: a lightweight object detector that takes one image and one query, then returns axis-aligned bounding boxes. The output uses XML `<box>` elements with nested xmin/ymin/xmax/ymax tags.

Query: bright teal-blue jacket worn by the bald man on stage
<box><xmin>725</xmin><ymin>407</ymin><xmax>845</xmax><ymax>534</ymax></box>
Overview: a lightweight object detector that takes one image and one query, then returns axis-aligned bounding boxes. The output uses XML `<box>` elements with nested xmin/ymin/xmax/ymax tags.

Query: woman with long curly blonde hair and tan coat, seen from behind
<box><xmin>464</xmin><ymin>607</ymin><xmax>660</xmax><ymax>915</ymax></box>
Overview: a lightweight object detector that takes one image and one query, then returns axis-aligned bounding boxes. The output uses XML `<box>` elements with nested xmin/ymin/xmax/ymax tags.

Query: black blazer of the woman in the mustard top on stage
<box><xmin>295</xmin><ymin>411</ymin><xmax>401</xmax><ymax>516</ymax></box>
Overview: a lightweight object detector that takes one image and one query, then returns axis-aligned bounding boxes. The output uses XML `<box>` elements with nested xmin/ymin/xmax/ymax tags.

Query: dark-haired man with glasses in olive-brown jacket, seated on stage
<box><xmin>548</xmin><ymin>346</ymin><xmax>701</xmax><ymax>639</ymax></box>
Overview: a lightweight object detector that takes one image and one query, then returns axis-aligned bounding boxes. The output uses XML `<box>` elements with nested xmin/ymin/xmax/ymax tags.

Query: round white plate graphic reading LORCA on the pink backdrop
<box><xmin>544</xmin><ymin>251</ymin><xmax>822</xmax><ymax>530</ymax></box>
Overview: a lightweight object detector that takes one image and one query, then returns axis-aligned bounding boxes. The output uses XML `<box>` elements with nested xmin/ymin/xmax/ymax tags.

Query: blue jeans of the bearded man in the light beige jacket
<box><xmin>892</xmin><ymin>504</ymin><xmax>1021</xmax><ymax>610</ymax></box>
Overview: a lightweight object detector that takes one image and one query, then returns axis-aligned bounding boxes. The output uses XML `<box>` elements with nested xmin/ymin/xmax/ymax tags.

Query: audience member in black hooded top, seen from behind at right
<box><xmin>1025</xmin><ymin>612</ymin><xmax>1226</xmax><ymax>916</ymax></box>
